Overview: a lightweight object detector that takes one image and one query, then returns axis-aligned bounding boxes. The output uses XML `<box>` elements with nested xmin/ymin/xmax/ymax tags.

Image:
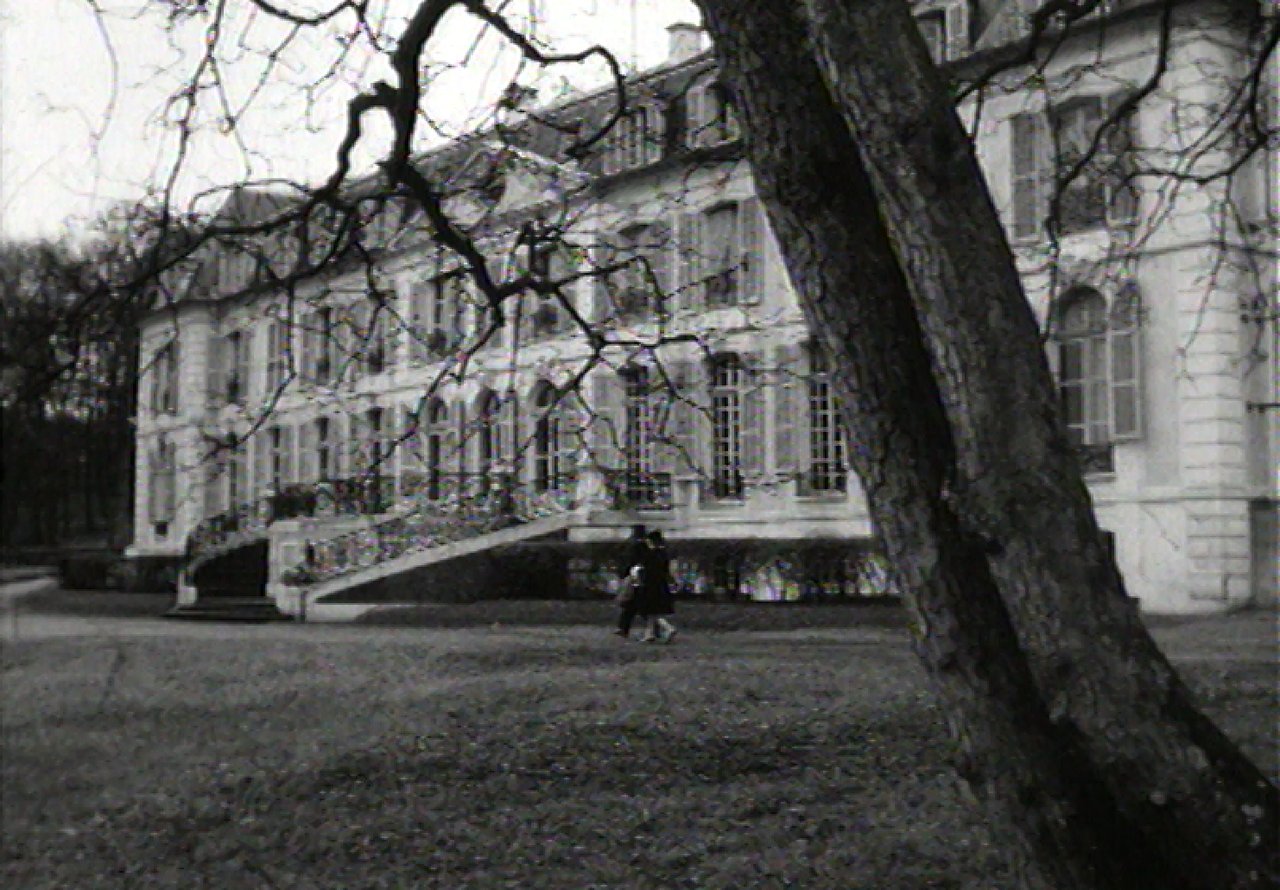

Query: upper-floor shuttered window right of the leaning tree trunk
<box><xmin>1010</xmin><ymin>96</ymin><xmax>1138</xmax><ymax>239</ymax></box>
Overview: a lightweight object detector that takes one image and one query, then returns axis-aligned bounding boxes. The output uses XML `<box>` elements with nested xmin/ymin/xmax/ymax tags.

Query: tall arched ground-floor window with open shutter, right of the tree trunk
<box><xmin>1055</xmin><ymin>284</ymin><xmax>1142</xmax><ymax>471</ymax></box>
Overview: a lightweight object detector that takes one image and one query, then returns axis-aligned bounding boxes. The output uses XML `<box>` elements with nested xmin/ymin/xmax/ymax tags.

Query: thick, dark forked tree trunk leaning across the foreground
<box><xmin>700</xmin><ymin>0</ymin><xmax>1280</xmax><ymax>890</ymax></box>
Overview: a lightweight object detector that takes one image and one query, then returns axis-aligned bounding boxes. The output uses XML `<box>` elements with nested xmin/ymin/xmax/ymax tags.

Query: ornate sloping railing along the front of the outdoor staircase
<box><xmin>290</xmin><ymin>475</ymin><xmax>573</xmax><ymax>587</ymax></box>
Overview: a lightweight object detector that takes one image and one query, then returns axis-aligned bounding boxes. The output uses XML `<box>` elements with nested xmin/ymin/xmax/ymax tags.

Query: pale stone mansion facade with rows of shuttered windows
<box><xmin>132</xmin><ymin>3</ymin><xmax>1280</xmax><ymax>612</ymax></box>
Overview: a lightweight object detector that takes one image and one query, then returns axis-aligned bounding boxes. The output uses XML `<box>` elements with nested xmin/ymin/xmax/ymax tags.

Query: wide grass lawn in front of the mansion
<box><xmin>0</xmin><ymin>611</ymin><xmax>1280</xmax><ymax>890</ymax></box>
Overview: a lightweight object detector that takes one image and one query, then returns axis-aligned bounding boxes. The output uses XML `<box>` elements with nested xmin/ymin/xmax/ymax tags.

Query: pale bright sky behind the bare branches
<box><xmin>0</xmin><ymin>0</ymin><xmax>698</xmax><ymax>239</ymax></box>
